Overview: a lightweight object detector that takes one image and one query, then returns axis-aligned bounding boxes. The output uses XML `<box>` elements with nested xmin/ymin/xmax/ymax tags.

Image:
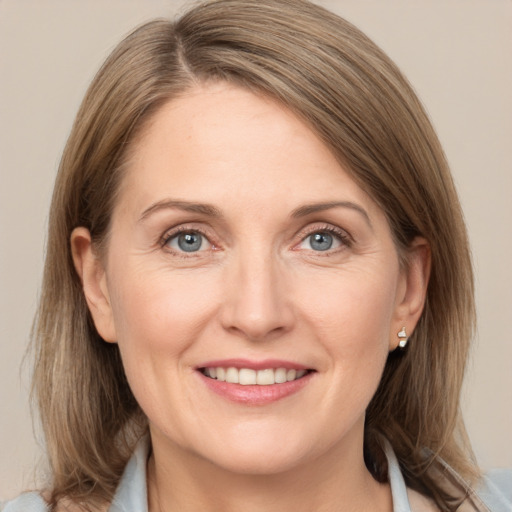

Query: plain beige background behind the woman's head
<box><xmin>0</xmin><ymin>0</ymin><xmax>512</xmax><ymax>498</ymax></box>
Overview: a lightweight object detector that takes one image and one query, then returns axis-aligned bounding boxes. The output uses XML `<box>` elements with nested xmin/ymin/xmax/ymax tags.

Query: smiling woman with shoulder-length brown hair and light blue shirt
<box><xmin>5</xmin><ymin>0</ymin><xmax>510</xmax><ymax>512</ymax></box>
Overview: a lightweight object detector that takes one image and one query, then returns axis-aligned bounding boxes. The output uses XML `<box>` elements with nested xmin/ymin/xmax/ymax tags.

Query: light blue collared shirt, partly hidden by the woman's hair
<box><xmin>0</xmin><ymin>438</ymin><xmax>512</xmax><ymax>512</ymax></box>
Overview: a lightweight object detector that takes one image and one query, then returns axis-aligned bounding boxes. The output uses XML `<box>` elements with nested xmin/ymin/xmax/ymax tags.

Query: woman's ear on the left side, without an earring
<box><xmin>70</xmin><ymin>227</ymin><xmax>117</xmax><ymax>343</ymax></box>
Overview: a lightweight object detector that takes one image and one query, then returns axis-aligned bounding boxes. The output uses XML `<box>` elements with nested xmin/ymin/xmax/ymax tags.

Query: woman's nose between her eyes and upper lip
<box><xmin>220</xmin><ymin>251</ymin><xmax>294</xmax><ymax>341</ymax></box>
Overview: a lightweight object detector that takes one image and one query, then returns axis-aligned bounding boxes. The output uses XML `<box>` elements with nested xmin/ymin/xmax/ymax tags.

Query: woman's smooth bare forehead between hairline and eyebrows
<box><xmin>114</xmin><ymin>83</ymin><xmax>382</xmax><ymax>222</ymax></box>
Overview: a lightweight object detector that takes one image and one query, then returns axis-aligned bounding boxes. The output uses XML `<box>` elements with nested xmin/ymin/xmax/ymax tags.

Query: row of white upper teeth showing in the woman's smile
<box><xmin>204</xmin><ymin>366</ymin><xmax>307</xmax><ymax>386</ymax></box>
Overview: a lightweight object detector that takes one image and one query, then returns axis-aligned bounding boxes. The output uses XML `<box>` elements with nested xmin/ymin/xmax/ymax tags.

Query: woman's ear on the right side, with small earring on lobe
<box><xmin>389</xmin><ymin>237</ymin><xmax>431</xmax><ymax>351</ymax></box>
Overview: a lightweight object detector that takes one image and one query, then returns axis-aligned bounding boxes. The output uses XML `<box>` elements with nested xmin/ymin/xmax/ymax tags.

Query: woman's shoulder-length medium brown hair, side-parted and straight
<box><xmin>33</xmin><ymin>0</ymin><xmax>477</xmax><ymax>510</ymax></box>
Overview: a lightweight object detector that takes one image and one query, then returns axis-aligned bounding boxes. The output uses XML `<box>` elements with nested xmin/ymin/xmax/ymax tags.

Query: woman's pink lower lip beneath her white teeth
<box><xmin>198</xmin><ymin>372</ymin><xmax>314</xmax><ymax>405</ymax></box>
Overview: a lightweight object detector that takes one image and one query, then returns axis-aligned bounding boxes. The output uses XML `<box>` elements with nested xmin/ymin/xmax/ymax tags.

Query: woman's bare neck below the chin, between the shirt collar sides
<box><xmin>148</xmin><ymin>430</ymin><xmax>393</xmax><ymax>512</ymax></box>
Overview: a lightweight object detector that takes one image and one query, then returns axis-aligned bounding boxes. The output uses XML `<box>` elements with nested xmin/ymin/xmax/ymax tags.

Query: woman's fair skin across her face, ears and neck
<box><xmin>72</xmin><ymin>83</ymin><xmax>429</xmax><ymax>512</ymax></box>
